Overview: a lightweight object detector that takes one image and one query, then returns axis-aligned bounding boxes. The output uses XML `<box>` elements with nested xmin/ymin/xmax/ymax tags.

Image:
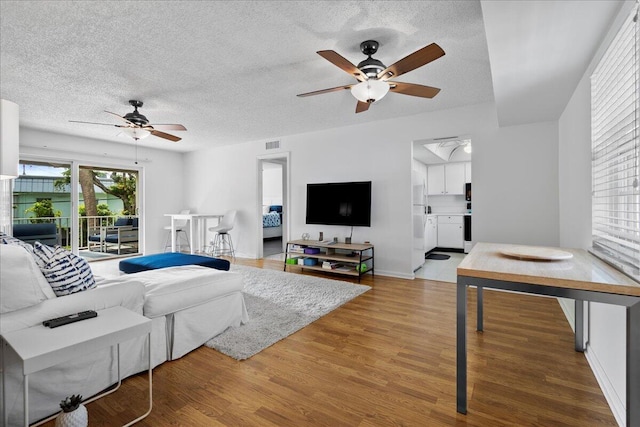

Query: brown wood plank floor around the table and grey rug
<box><xmin>47</xmin><ymin>260</ymin><xmax>616</xmax><ymax>427</ymax></box>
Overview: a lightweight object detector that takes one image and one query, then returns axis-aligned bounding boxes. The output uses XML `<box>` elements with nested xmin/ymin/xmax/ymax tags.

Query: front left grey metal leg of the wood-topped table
<box><xmin>456</xmin><ymin>277</ymin><xmax>467</xmax><ymax>414</ymax></box>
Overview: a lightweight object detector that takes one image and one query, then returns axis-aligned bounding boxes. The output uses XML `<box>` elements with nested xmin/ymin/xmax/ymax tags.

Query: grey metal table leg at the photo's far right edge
<box><xmin>627</xmin><ymin>302</ymin><xmax>640</xmax><ymax>427</ymax></box>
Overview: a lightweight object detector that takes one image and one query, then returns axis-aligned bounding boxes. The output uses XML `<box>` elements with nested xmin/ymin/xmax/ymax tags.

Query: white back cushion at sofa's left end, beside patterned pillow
<box><xmin>0</xmin><ymin>244</ymin><xmax>56</xmax><ymax>313</ymax></box>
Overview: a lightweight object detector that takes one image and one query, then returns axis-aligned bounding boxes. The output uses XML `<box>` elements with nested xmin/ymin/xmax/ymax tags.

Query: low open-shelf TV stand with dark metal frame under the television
<box><xmin>284</xmin><ymin>240</ymin><xmax>374</xmax><ymax>282</ymax></box>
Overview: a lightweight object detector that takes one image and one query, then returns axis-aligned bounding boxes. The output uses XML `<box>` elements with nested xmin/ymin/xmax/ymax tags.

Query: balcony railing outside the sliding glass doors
<box><xmin>13</xmin><ymin>215</ymin><xmax>137</xmax><ymax>249</ymax></box>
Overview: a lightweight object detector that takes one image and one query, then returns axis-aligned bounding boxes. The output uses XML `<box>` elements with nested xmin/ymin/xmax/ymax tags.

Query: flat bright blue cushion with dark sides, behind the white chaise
<box><xmin>120</xmin><ymin>252</ymin><xmax>231</xmax><ymax>273</ymax></box>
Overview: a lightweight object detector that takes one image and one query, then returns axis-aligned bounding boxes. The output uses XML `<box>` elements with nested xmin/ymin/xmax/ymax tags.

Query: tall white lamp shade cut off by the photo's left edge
<box><xmin>0</xmin><ymin>99</ymin><xmax>20</xmax><ymax>179</ymax></box>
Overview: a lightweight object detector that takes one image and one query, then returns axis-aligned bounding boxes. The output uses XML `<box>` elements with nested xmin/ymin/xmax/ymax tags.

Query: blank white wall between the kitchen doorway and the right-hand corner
<box><xmin>472</xmin><ymin>122</ymin><xmax>559</xmax><ymax>246</ymax></box>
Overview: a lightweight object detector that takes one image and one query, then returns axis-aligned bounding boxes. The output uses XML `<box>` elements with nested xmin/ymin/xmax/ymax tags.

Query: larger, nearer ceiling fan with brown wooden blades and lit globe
<box><xmin>298</xmin><ymin>40</ymin><xmax>444</xmax><ymax>113</ymax></box>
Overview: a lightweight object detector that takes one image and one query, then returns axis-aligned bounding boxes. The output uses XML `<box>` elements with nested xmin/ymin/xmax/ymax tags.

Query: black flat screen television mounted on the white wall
<box><xmin>307</xmin><ymin>181</ymin><xmax>371</xmax><ymax>227</ymax></box>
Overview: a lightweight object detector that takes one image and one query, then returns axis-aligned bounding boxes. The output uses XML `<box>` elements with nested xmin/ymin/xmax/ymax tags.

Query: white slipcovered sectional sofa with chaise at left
<box><xmin>0</xmin><ymin>244</ymin><xmax>248</xmax><ymax>425</ymax></box>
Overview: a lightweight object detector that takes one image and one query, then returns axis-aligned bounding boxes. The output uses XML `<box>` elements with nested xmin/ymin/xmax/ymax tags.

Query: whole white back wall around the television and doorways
<box><xmin>184</xmin><ymin>104</ymin><xmax>558</xmax><ymax>277</ymax></box>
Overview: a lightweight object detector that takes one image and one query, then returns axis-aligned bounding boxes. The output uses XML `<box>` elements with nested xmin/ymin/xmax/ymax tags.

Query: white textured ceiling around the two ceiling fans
<box><xmin>0</xmin><ymin>0</ymin><xmax>493</xmax><ymax>151</ymax></box>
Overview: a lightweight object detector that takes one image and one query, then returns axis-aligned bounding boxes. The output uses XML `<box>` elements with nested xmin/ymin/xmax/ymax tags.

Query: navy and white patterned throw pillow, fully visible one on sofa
<box><xmin>33</xmin><ymin>242</ymin><xmax>96</xmax><ymax>296</ymax></box>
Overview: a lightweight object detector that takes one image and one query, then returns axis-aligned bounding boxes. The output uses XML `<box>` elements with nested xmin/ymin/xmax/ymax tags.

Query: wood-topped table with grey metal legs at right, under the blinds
<box><xmin>456</xmin><ymin>243</ymin><xmax>640</xmax><ymax>427</ymax></box>
